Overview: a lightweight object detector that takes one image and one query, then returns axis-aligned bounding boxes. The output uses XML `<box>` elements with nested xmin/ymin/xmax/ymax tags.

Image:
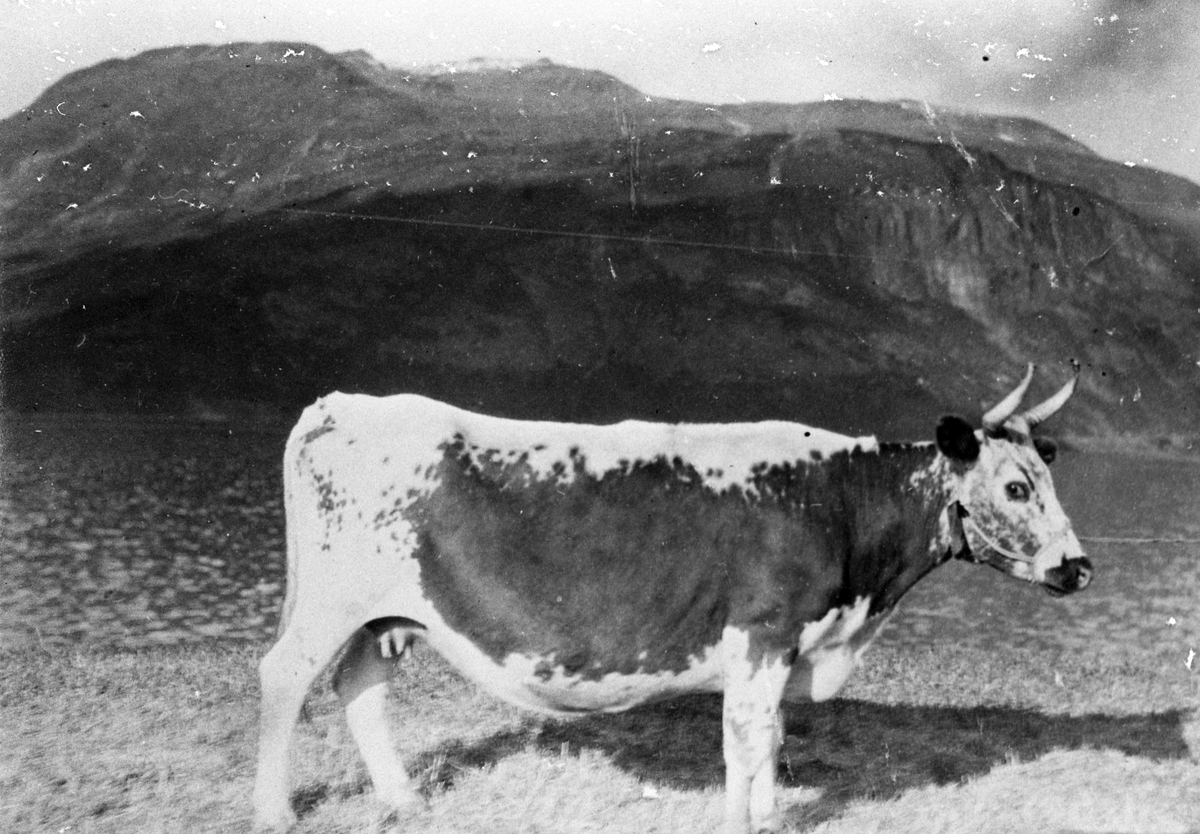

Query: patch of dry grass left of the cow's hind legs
<box><xmin>0</xmin><ymin>649</ymin><xmax>256</xmax><ymax>834</ymax></box>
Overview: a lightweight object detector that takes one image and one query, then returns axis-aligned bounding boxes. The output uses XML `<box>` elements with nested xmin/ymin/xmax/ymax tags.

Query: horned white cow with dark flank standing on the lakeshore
<box><xmin>253</xmin><ymin>365</ymin><xmax>1092</xmax><ymax>834</ymax></box>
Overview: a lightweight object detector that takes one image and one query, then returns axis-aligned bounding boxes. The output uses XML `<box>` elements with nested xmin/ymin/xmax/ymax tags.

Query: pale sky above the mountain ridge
<box><xmin>7</xmin><ymin>0</ymin><xmax>1200</xmax><ymax>182</ymax></box>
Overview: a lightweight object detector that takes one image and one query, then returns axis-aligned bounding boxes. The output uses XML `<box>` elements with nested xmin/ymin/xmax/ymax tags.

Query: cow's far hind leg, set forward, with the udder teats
<box><xmin>334</xmin><ymin>620</ymin><xmax>421</xmax><ymax>812</ymax></box>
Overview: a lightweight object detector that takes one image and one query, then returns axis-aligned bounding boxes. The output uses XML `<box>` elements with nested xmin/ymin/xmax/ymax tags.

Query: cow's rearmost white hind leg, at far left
<box><xmin>253</xmin><ymin>618</ymin><xmax>348</xmax><ymax>830</ymax></box>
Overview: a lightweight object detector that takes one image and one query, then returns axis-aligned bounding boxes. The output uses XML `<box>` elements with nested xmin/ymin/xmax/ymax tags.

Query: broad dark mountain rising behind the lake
<box><xmin>0</xmin><ymin>43</ymin><xmax>1200</xmax><ymax>448</ymax></box>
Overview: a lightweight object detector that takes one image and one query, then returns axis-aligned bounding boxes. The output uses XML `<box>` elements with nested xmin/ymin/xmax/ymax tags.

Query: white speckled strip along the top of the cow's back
<box><xmin>302</xmin><ymin>394</ymin><xmax>878</xmax><ymax>501</ymax></box>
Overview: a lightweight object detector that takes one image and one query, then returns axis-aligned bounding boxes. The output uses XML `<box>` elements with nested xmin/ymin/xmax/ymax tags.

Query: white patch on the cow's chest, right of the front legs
<box><xmin>784</xmin><ymin>596</ymin><xmax>890</xmax><ymax>701</ymax></box>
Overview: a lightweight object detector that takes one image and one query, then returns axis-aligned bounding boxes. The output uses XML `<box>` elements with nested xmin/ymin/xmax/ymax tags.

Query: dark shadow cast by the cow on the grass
<box><xmin>413</xmin><ymin>695</ymin><xmax>1190</xmax><ymax>827</ymax></box>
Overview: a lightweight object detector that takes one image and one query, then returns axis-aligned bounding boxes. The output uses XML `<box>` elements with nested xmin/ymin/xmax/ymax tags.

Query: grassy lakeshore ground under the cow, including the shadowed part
<box><xmin>0</xmin><ymin>644</ymin><xmax>1200</xmax><ymax>834</ymax></box>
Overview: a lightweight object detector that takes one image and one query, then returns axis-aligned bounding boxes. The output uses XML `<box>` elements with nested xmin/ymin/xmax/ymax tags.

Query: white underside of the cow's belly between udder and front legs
<box><xmin>426</xmin><ymin>629</ymin><xmax>722</xmax><ymax>714</ymax></box>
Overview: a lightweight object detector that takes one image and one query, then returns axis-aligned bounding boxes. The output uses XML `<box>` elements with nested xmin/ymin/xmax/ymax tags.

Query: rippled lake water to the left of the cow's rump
<box><xmin>0</xmin><ymin>416</ymin><xmax>287</xmax><ymax>646</ymax></box>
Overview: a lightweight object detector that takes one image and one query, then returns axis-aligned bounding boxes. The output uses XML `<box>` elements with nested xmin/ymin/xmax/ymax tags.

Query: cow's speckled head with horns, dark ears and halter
<box><xmin>937</xmin><ymin>365</ymin><xmax>1092</xmax><ymax>594</ymax></box>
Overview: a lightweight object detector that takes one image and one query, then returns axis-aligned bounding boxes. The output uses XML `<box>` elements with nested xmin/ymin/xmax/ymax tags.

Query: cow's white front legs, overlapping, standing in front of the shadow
<box><xmin>722</xmin><ymin>628</ymin><xmax>791</xmax><ymax>834</ymax></box>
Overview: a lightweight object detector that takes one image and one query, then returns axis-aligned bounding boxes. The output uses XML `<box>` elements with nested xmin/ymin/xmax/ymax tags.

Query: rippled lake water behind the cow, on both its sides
<box><xmin>0</xmin><ymin>416</ymin><xmax>1200</xmax><ymax>662</ymax></box>
